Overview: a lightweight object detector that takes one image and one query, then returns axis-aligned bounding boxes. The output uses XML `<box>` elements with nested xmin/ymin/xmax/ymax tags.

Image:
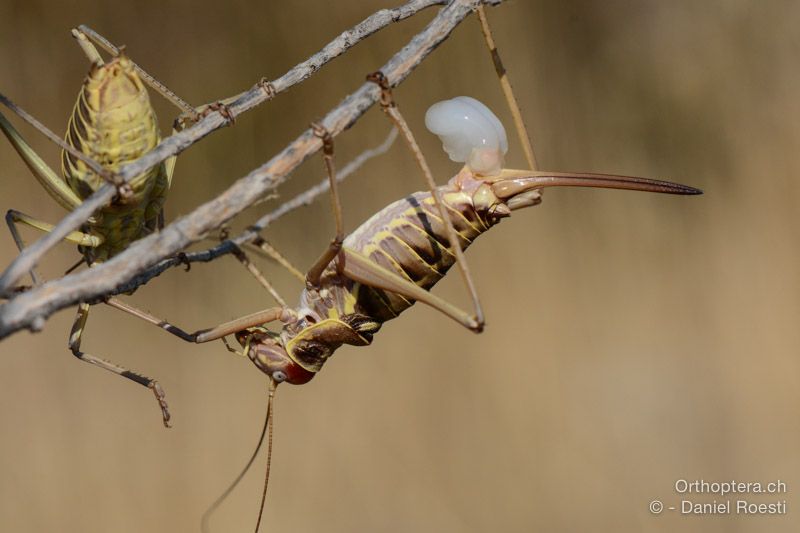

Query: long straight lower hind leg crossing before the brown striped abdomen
<box><xmin>367</xmin><ymin>72</ymin><xmax>484</xmax><ymax>332</ymax></box>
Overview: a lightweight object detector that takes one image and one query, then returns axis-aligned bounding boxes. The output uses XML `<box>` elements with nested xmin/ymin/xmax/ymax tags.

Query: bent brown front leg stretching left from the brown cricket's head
<box><xmin>106</xmin><ymin>298</ymin><xmax>292</xmax><ymax>343</ymax></box>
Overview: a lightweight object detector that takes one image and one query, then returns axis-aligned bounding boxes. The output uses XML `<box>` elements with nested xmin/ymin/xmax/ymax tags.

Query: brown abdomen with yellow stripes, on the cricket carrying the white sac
<box><xmin>344</xmin><ymin>186</ymin><xmax>493</xmax><ymax>321</ymax></box>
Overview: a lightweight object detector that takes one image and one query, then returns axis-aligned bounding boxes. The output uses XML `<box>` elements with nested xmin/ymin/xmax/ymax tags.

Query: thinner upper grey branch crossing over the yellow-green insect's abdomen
<box><xmin>0</xmin><ymin>0</ymin><xmax>446</xmax><ymax>295</ymax></box>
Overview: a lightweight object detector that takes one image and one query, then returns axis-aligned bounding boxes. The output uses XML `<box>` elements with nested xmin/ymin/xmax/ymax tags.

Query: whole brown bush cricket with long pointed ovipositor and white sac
<box><xmin>92</xmin><ymin>7</ymin><xmax>700</xmax><ymax>528</ymax></box>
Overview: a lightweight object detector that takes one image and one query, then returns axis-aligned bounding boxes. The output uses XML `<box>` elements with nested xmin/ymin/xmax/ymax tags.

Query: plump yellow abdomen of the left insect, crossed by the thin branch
<box><xmin>61</xmin><ymin>56</ymin><xmax>169</xmax><ymax>261</ymax></box>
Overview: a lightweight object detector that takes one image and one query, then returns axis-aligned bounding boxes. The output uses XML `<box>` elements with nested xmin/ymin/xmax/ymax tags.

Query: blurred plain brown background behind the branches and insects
<box><xmin>0</xmin><ymin>0</ymin><xmax>800</xmax><ymax>532</ymax></box>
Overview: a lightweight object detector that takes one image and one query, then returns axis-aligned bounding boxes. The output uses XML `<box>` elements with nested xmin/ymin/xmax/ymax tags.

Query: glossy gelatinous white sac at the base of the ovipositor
<box><xmin>425</xmin><ymin>96</ymin><xmax>508</xmax><ymax>175</ymax></box>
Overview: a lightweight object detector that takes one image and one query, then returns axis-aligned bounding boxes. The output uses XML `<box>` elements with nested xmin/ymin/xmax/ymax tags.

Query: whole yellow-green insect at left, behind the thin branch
<box><xmin>0</xmin><ymin>26</ymin><xmax>186</xmax><ymax>426</ymax></box>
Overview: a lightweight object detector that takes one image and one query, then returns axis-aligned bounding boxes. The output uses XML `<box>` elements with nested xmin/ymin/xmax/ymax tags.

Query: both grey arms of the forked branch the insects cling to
<box><xmin>0</xmin><ymin>0</ymin><xmax>501</xmax><ymax>338</ymax></box>
